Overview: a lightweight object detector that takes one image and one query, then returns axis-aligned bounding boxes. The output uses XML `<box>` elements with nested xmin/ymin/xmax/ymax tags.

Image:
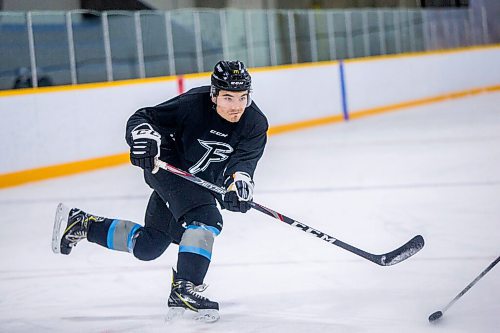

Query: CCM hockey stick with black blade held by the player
<box><xmin>153</xmin><ymin>160</ymin><xmax>424</xmax><ymax>266</ymax></box>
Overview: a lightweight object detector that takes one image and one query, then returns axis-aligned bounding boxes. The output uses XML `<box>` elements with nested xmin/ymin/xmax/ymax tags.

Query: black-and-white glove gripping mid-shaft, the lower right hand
<box><xmin>222</xmin><ymin>171</ymin><xmax>254</xmax><ymax>213</ymax></box>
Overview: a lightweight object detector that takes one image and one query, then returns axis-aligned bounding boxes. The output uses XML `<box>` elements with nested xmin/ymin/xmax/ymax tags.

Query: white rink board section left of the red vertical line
<box><xmin>0</xmin><ymin>80</ymin><xmax>177</xmax><ymax>174</ymax></box>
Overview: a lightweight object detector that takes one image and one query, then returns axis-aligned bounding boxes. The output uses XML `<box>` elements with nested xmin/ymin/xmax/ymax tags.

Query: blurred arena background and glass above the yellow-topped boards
<box><xmin>0</xmin><ymin>0</ymin><xmax>500</xmax><ymax>89</ymax></box>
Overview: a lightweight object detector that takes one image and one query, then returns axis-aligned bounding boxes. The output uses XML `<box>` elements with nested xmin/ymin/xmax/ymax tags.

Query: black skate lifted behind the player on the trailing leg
<box><xmin>52</xmin><ymin>203</ymin><xmax>96</xmax><ymax>254</ymax></box>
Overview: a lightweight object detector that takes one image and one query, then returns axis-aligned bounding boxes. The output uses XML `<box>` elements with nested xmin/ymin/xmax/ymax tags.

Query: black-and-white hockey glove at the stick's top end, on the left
<box><xmin>130</xmin><ymin>123</ymin><xmax>161</xmax><ymax>171</ymax></box>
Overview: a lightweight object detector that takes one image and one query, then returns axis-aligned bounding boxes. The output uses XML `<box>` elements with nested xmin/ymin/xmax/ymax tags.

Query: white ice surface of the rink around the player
<box><xmin>0</xmin><ymin>93</ymin><xmax>500</xmax><ymax>333</ymax></box>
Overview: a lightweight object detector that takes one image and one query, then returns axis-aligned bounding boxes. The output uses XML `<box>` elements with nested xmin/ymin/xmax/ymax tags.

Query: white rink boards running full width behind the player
<box><xmin>0</xmin><ymin>47</ymin><xmax>500</xmax><ymax>174</ymax></box>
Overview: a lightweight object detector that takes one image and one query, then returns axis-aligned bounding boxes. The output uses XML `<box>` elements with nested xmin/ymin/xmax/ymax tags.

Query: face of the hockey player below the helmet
<box><xmin>213</xmin><ymin>90</ymin><xmax>249</xmax><ymax>123</ymax></box>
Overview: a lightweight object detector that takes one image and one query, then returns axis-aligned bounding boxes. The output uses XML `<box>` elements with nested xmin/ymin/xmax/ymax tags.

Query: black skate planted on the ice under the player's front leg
<box><xmin>167</xmin><ymin>271</ymin><xmax>219</xmax><ymax>323</ymax></box>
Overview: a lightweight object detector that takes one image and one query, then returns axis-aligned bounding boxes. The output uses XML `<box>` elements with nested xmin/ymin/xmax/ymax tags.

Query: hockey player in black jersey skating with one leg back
<box><xmin>53</xmin><ymin>61</ymin><xmax>268</xmax><ymax>321</ymax></box>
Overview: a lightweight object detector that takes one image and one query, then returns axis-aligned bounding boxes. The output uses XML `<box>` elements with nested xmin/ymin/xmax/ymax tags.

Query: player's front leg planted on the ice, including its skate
<box><xmin>145</xmin><ymin>170</ymin><xmax>222</xmax><ymax>321</ymax></box>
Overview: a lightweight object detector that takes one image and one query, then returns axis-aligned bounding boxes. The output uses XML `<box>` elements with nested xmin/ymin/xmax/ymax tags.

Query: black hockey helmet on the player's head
<box><xmin>211</xmin><ymin>60</ymin><xmax>252</xmax><ymax>96</ymax></box>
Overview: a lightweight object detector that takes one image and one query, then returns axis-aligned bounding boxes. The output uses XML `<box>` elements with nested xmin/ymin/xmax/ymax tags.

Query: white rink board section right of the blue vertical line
<box><xmin>345</xmin><ymin>48</ymin><xmax>500</xmax><ymax>112</ymax></box>
